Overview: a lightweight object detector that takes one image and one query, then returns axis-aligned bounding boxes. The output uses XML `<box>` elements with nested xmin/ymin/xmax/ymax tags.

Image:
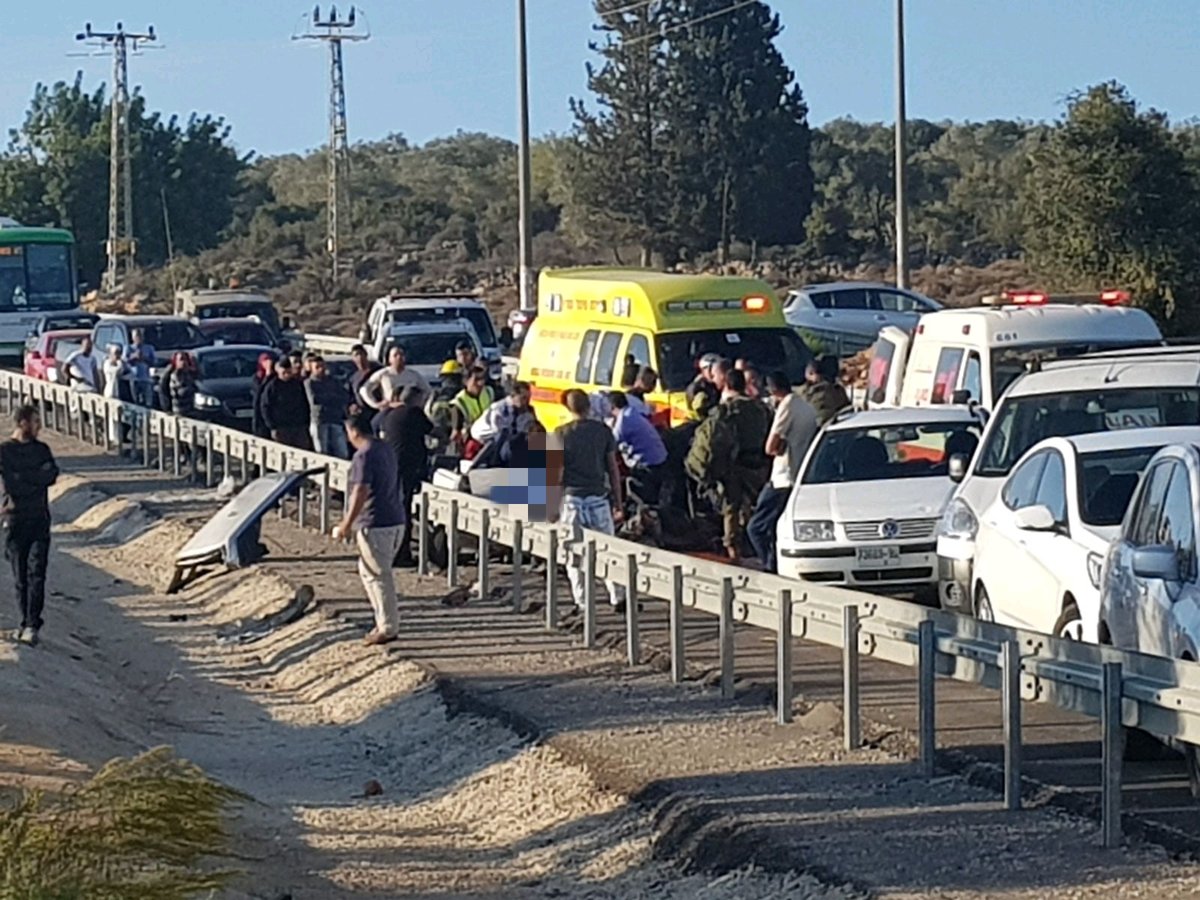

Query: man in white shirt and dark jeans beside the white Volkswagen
<box><xmin>746</xmin><ymin>372</ymin><xmax>820</xmax><ymax>572</ymax></box>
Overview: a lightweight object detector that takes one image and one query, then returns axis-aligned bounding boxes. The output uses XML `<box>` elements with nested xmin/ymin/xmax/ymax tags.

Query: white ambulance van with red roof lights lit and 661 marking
<box><xmin>866</xmin><ymin>290</ymin><xmax>1163</xmax><ymax>409</ymax></box>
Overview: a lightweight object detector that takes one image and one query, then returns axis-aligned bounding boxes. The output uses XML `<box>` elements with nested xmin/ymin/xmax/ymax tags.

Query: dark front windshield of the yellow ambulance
<box><xmin>656</xmin><ymin>328</ymin><xmax>812</xmax><ymax>391</ymax></box>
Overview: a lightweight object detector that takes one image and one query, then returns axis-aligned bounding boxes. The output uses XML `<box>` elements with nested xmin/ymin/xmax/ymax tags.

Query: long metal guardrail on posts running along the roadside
<box><xmin>0</xmin><ymin>364</ymin><xmax>1200</xmax><ymax>846</ymax></box>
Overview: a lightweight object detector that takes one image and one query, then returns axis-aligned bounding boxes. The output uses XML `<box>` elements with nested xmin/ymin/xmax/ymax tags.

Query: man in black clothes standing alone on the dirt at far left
<box><xmin>0</xmin><ymin>406</ymin><xmax>59</xmax><ymax>646</ymax></box>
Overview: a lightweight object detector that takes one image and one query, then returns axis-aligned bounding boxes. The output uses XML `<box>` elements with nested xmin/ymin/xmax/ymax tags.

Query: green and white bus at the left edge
<box><xmin>0</xmin><ymin>216</ymin><xmax>79</xmax><ymax>358</ymax></box>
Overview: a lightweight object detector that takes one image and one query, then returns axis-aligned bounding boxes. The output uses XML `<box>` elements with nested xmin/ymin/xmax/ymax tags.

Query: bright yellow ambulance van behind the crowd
<box><xmin>517</xmin><ymin>269</ymin><xmax>812</xmax><ymax>428</ymax></box>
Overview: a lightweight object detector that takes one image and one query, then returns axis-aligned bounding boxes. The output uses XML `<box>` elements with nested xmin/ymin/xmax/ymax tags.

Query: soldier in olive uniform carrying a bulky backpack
<box><xmin>684</xmin><ymin>370</ymin><xmax>772</xmax><ymax>562</ymax></box>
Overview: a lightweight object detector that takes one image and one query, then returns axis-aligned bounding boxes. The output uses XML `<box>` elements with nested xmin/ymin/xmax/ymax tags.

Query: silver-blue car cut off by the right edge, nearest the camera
<box><xmin>1099</xmin><ymin>444</ymin><xmax>1200</xmax><ymax>799</ymax></box>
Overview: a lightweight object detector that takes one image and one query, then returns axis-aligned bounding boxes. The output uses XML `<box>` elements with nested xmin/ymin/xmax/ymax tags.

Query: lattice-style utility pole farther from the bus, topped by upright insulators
<box><xmin>292</xmin><ymin>6</ymin><xmax>371</xmax><ymax>282</ymax></box>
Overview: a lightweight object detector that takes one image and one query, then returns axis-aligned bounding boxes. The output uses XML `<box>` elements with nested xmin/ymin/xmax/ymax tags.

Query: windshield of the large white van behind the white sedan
<box><xmin>974</xmin><ymin>388</ymin><xmax>1200</xmax><ymax>478</ymax></box>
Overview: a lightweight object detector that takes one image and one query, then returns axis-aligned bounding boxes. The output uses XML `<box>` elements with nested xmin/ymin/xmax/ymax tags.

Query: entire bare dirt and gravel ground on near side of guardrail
<box><xmin>0</xmin><ymin>440</ymin><xmax>1200</xmax><ymax>900</ymax></box>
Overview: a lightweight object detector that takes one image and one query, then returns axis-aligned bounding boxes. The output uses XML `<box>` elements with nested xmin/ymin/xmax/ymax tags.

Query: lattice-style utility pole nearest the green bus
<box><xmin>76</xmin><ymin>22</ymin><xmax>158</xmax><ymax>293</ymax></box>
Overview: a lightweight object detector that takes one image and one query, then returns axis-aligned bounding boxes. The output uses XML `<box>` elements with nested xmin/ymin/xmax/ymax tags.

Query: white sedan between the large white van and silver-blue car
<box><xmin>974</xmin><ymin>426</ymin><xmax>1200</xmax><ymax>642</ymax></box>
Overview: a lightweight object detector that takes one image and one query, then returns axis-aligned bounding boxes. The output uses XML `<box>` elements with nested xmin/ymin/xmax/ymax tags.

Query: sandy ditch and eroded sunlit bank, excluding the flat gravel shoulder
<box><xmin>0</xmin><ymin>479</ymin><xmax>848</xmax><ymax>900</ymax></box>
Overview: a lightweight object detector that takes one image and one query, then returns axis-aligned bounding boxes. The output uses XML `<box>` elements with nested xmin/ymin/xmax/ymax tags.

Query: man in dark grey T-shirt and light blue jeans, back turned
<box><xmin>556</xmin><ymin>389</ymin><xmax>624</xmax><ymax>611</ymax></box>
